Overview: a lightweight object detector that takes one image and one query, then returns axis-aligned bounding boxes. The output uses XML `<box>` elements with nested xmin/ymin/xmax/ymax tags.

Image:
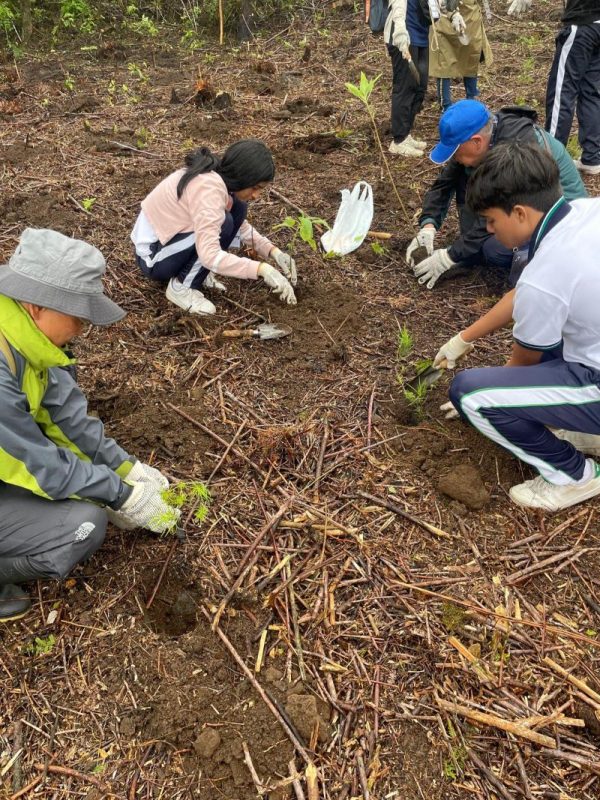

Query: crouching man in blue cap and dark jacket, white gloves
<box><xmin>406</xmin><ymin>100</ymin><xmax>587</xmax><ymax>289</ymax></box>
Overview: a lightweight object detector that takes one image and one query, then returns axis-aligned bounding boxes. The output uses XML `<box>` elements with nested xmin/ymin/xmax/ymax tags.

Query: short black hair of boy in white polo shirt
<box><xmin>467</xmin><ymin>142</ymin><xmax>562</xmax><ymax>214</ymax></box>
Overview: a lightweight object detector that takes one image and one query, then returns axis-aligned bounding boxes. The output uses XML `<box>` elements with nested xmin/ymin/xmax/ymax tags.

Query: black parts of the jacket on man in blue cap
<box><xmin>419</xmin><ymin>110</ymin><xmax>537</xmax><ymax>262</ymax></box>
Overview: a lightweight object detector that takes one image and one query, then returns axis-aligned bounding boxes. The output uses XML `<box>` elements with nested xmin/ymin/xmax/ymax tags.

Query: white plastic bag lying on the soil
<box><xmin>321</xmin><ymin>181</ymin><xmax>373</xmax><ymax>256</ymax></box>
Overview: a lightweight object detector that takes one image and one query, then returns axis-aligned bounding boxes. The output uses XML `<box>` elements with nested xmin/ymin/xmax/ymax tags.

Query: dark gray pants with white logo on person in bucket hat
<box><xmin>0</xmin><ymin>482</ymin><xmax>107</xmax><ymax>584</ymax></box>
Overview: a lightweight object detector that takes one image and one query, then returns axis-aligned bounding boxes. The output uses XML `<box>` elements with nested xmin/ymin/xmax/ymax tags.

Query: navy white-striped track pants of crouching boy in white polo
<box><xmin>450</xmin><ymin>358</ymin><xmax>600</xmax><ymax>486</ymax></box>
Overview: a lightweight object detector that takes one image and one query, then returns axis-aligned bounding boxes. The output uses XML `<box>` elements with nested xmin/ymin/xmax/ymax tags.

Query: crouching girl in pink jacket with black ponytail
<box><xmin>131</xmin><ymin>139</ymin><xmax>296</xmax><ymax>314</ymax></box>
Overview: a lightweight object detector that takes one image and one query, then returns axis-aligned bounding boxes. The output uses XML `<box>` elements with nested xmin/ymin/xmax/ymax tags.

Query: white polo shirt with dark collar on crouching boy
<box><xmin>513</xmin><ymin>198</ymin><xmax>600</xmax><ymax>372</ymax></box>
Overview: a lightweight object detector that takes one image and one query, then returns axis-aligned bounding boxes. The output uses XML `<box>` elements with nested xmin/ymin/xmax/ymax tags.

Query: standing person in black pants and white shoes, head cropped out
<box><xmin>383</xmin><ymin>0</ymin><xmax>430</xmax><ymax>157</ymax></box>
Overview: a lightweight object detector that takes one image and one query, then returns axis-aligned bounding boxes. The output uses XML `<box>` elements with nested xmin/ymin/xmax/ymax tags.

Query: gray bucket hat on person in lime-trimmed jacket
<box><xmin>0</xmin><ymin>228</ymin><xmax>126</xmax><ymax>325</ymax></box>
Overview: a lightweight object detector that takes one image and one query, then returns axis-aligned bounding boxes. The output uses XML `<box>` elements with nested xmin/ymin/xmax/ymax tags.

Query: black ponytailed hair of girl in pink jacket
<box><xmin>177</xmin><ymin>139</ymin><xmax>275</xmax><ymax>199</ymax></box>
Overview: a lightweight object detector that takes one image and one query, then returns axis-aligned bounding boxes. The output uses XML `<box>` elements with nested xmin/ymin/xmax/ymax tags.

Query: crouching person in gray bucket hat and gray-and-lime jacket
<box><xmin>0</xmin><ymin>228</ymin><xmax>179</xmax><ymax>622</ymax></box>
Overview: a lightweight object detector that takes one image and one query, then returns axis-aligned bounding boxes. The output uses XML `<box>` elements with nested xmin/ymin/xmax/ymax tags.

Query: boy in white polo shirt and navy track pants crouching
<box><xmin>450</xmin><ymin>143</ymin><xmax>600</xmax><ymax>511</ymax></box>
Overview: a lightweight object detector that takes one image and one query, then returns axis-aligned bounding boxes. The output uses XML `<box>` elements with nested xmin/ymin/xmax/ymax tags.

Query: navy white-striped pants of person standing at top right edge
<box><xmin>546</xmin><ymin>23</ymin><xmax>600</xmax><ymax>165</ymax></box>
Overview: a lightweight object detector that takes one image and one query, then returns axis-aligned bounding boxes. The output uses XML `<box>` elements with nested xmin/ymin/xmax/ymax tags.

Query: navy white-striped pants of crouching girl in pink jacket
<box><xmin>136</xmin><ymin>197</ymin><xmax>248</xmax><ymax>289</ymax></box>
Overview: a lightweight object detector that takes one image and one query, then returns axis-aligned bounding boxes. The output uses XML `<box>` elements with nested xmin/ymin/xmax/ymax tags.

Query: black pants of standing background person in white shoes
<box><xmin>388</xmin><ymin>44</ymin><xmax>429</xmax><ymax>142</ymax></box>
